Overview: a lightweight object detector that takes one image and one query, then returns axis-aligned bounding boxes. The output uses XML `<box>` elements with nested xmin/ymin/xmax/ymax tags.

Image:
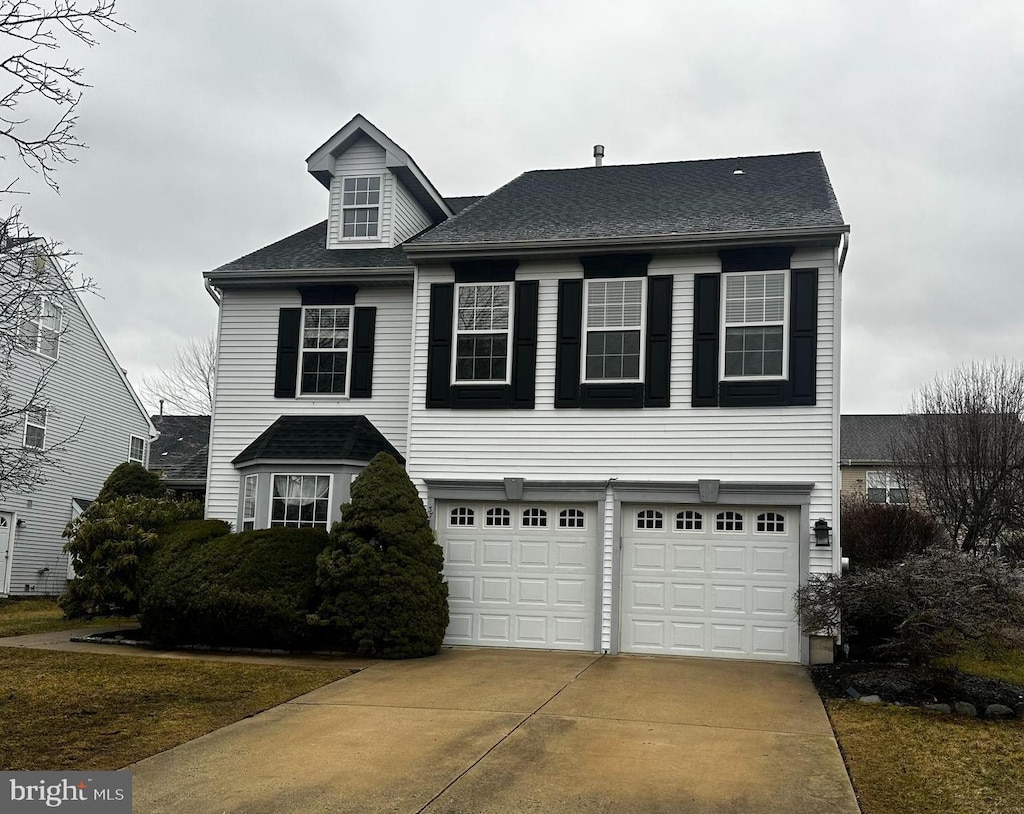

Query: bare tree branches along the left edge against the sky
<box><xmin>0</xmin><ymin>0</ymin><xmax>128</xmax><ymax>496</ymax></box>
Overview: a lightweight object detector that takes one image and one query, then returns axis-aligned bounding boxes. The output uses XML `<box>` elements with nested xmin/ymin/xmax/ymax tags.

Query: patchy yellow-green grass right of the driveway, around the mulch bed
<box><xmin>825</xmin><ymin>645</ymin><xmax>1024</xmax><ymax>814</ymax></box>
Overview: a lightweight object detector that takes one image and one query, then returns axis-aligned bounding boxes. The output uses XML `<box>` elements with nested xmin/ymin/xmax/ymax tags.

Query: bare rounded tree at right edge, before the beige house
<box><xmin>893</xmin><ymin>360</ymin><xmax>1024</xmax><ymax>554</ymax></box>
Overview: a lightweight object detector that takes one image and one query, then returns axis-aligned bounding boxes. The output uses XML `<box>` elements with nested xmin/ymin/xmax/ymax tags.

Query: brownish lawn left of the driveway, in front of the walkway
<box><xmin>0</xmin><ymin>647</ymin><xmax>351</xmax><ymax>771</ymax></box>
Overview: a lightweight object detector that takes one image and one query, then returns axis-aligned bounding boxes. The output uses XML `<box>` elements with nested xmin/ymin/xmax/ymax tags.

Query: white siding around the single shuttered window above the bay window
<box><xmin>207</xmin><ymin>287</ymin><xmax>413</xmax><ymax>523</ymax></box>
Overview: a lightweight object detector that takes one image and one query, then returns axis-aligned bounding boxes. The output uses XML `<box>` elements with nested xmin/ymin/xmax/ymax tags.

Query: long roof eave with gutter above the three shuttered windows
<box><xmin>402</xmin><ymin>223</ymin><xmax>850</xmax><ymax>260</ymax></box>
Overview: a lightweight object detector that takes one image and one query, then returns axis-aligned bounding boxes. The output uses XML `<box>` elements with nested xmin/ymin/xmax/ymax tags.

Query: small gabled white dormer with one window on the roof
<box><xmin>306</xmin><ymin>114</ymin><xmax>454</xmax><ymax>249</ymax></box>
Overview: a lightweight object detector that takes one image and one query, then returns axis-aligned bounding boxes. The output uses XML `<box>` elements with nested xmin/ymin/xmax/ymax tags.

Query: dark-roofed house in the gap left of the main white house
<box><xmin>150</xmin><ymin>416</ymin><xmax>210</xmax><ymax>501</ymax></box>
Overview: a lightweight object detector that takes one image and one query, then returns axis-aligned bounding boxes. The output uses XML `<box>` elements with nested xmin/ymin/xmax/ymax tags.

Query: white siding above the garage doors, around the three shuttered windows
<box><xmin>409</xmin><ymin>248</ymin><xmax>838</xmax><ymax>572</ymax></box>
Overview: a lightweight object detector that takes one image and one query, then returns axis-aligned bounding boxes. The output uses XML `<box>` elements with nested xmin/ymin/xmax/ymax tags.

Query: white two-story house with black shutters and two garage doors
<box><xmin>205</xmin><ymin>116</ymin><xmax>848</xmax><ymax>662</ymax></box>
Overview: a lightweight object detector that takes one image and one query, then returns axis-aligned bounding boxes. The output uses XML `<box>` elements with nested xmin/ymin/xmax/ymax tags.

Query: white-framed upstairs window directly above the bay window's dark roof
<box><xmin>299</xmin><ymin>305</ymin><xmax>352</xmax><ymax>395</ymax></box>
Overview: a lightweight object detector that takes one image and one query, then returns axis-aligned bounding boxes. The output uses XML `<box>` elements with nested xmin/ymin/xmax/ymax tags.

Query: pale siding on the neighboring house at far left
<box><xmin>0</xmin><ymin>295</ymin><xmax>151</xmax><ymax>597</ymax></box>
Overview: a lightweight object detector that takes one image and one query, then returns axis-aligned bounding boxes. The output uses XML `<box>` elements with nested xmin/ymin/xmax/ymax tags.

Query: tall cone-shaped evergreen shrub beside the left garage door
<box><xmin>317</xmin><ymin>453</ymin><xmax>449</xmax><ymax>658</ymax></box>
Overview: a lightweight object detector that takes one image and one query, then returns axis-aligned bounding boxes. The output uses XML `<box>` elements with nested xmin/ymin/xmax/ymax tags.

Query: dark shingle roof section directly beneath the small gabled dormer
<box><xmin>214</xmin><ymin>220</ymin><xmax>412</xmax><ymax>271</ymax></box>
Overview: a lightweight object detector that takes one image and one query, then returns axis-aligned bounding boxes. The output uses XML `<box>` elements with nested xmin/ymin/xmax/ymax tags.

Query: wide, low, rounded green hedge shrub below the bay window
<box><xmin>139</xmin><ymin>525</ymin><xmax>328</xmax><ymax>650</ymax></box>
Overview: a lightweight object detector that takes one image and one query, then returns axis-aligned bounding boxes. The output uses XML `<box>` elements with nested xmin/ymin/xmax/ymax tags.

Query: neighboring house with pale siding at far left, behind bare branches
<box><xmin>0</xmin><ymin>261</ymin><xmax>153</xmax><ymax>596</ymax></box>
